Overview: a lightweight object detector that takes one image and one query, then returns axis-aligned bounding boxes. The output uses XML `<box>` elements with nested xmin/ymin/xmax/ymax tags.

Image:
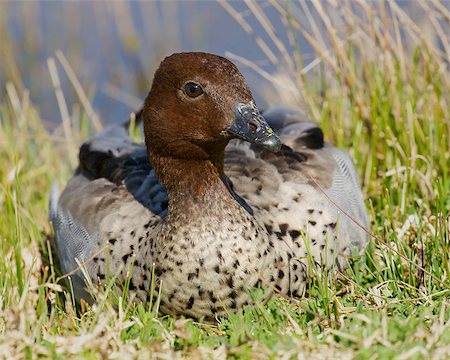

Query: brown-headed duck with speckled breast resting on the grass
<box><xmin>49</xmin><ymin>52</ymin><xmax>369</xmax><ymax>318</ymax></box>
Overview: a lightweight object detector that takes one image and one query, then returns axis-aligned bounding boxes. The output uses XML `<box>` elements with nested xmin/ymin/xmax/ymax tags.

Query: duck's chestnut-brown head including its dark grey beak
<box><xmin>143</xmin><ymin>53</ymin><xmax>281</xmax><ymax>160</ymax></box>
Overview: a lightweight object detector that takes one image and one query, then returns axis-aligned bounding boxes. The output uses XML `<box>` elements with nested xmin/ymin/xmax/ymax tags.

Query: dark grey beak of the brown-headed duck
<box><xmin>227</xmin><ymin>101</ymin><xmax>281</xmax><ymax>152</ymax></box>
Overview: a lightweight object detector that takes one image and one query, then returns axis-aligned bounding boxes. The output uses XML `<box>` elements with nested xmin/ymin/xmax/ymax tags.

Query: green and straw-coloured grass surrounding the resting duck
<box><xmin>0</xmin><ymin>2</ymin><xmax>450</xmax><ymax>359</ymax></box>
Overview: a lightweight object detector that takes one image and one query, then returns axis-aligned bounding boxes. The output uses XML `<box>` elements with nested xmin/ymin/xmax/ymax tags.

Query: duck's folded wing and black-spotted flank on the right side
<box><xmin>225</xmin><ymin>107</ymin><xmax>368</xmax><ymax>272</ymax></box>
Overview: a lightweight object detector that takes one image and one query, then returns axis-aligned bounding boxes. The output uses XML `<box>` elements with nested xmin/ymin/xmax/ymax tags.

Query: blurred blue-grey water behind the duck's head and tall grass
<box><xmin>0</xmin><ymin>0</ymin><xmax>442</xmax><ymax>123</ymax></box>
